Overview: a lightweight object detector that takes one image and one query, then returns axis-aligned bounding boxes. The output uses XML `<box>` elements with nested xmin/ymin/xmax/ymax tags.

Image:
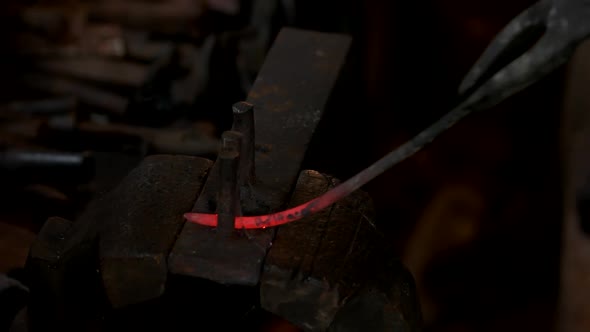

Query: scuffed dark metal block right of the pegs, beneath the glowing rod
<box><xmin>260</xmin><ymin>171</ymin><xmax>379</xmax><ymax>331</ymax></box>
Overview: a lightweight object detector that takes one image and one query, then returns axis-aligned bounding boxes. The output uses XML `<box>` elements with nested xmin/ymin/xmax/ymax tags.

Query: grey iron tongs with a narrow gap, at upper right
<box><xmin>459</xmin><ymin>0</ymin><xmax>590</xmax><ymax>109</ymax></box>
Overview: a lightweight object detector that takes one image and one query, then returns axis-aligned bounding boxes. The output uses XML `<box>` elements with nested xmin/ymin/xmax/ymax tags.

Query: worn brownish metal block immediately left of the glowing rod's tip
<box><xmin>100</xmin><ymin>155</ymin><xmax>213</xmax><ymax>307</ymax></box>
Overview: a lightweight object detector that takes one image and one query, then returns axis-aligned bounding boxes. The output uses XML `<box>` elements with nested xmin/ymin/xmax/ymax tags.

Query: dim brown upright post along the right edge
<box><xmin>558</xmin><ymin>41</ymin><xmax>590</xmax><ymax>332</ymax></box>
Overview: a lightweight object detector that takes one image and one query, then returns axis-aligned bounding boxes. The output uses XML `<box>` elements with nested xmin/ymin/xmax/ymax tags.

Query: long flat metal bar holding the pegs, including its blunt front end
<box><xmin>169</xmin><ymin>28</ymin><xmax>350</xmax><ymax>285</ymax></box>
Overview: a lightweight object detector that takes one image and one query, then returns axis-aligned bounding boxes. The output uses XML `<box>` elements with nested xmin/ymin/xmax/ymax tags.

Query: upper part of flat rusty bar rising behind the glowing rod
<box><xmin>247</xmin><ymin>28</ymin><xmax>351</xmax><ymax>212</ymax></box>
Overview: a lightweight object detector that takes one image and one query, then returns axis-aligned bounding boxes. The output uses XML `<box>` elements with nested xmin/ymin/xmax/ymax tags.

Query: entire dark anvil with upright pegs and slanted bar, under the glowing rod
<box><xmin>23</xmin><ymin>29</ymin><xmax>420</xmax><ymax>331</ymax></box>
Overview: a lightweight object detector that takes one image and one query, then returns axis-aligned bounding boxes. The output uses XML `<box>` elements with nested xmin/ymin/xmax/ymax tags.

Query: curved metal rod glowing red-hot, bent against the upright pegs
<box><xmin>184</xmin><ymin>103</ymin><xmax>471</xmax><ymax>229</ymax></box>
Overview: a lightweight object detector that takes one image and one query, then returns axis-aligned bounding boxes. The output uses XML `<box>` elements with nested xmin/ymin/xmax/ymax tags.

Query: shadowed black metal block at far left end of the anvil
<box><xmin>26</xmin><ymin>170</ymin><xmax>134</xmax><ymax>331</ymax></box>
